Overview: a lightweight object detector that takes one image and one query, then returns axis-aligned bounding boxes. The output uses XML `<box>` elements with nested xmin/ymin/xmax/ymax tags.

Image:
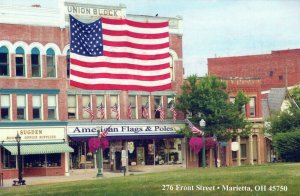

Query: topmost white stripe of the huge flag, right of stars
<box><xmin>102</xmin><ymin>22</ymin><xmax>169</xmax><ymax>34</ymax></box>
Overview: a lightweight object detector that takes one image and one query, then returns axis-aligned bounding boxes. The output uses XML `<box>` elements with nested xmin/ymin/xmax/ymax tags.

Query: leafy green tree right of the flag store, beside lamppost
<box><xmin>176</xmin><ymin>75</ymin><xmax>250</xmax><ymax>141</ymax></box>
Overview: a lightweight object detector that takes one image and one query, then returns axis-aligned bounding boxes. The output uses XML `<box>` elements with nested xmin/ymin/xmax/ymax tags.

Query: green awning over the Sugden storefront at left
<box><xmin>3</xmin><ymin>143</ymin><xmax>74</xmax><ymax>155</ymax></box>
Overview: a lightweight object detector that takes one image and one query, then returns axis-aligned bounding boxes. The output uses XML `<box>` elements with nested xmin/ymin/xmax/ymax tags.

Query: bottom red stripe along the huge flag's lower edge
<box><xmin>70</xmin><ymin>80</ymin><xmax>171</xmax><ymax>92</ymax></box>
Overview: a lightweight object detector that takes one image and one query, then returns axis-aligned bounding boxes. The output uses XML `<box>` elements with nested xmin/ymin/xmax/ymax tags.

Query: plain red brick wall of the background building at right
<box><xmin>208</xmin><ymin>49</ymin><xmax>300</xmax><ymax>91</ymax></box>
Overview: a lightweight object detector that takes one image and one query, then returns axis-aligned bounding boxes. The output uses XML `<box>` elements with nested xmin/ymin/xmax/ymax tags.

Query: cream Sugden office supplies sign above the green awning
<box><xmin>0</xmin><ymin>127</ymin><xmax>65</xmax><ymax>142</ymax></box>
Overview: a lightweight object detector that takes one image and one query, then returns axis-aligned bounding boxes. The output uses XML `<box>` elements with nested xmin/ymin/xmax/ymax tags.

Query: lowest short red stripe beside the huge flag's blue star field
<box><xmin>103</xmin><ymin>51</ymin><xmax>170</xmax><ymax>60</ymax></box>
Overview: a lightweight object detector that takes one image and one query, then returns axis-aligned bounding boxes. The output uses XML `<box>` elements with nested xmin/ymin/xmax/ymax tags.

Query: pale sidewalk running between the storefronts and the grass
<box><xmin>4</xmin><ymin>165</ymin><xmax>184</xmax><ymax>187</ymax></box>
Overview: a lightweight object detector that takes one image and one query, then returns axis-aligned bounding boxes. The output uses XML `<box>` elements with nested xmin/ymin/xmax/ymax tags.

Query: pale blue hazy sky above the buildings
<box><xmin>0</xmin><ymin>0</ymin><xmax>300</xmax><ymax>76</ymax></box>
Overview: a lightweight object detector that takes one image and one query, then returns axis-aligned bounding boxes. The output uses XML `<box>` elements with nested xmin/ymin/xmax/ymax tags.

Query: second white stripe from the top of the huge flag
<box><xmin>103</xmin><ymin>34</ymin><xmax>169</xmax><ymax>45</ymax></box>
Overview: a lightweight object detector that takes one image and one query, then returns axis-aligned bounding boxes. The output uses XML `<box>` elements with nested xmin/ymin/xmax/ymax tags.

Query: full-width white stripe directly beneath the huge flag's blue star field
<box><xmin>70</xmin><ymin>52</ymin><xmax>171</xmax><ymax>66</ymax></box>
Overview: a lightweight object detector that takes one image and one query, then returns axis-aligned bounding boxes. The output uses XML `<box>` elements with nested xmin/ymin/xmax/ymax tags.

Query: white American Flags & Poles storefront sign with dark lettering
<box><xmin>67</xmin><ymin>125</ymin><xmax>184</xmax><ymax>136</ymax></box>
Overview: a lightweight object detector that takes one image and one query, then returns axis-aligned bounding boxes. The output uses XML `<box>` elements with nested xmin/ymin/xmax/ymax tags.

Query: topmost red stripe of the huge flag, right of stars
<box><xmin>101</xmin><ymin>17</ymin><xmax>169</xmax><ymax>28</ymax></box>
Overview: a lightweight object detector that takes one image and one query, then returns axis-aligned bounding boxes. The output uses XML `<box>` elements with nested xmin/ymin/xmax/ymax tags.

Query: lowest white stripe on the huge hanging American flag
<box><xmin>70</xmin><ymin>75</ymin><xmax>171</xmax><ymax>87</ymax></box>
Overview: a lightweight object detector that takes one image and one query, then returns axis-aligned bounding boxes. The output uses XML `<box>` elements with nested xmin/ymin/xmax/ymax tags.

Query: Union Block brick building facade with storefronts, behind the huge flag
<box><xmin>0</xmin><ymin>1</ymin><xmax>185</xmax><ymax>178</ymax></box>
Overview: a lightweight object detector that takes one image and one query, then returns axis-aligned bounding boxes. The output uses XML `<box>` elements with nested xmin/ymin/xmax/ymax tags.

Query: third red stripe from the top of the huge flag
<box><xmin>103</xmin><ymin>40</ymin><xmax>169</xmax><ymax>50</ymax></box>
